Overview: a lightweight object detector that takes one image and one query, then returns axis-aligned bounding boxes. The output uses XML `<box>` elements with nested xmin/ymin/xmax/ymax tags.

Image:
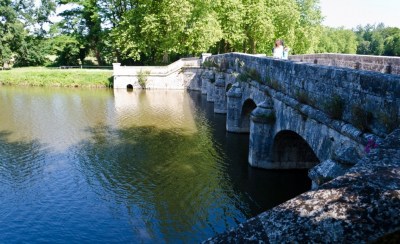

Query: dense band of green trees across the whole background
<box><xmin>0</xmin><ymin>0</ymin><xmax>400</xmax><ymax>66</ymax></box>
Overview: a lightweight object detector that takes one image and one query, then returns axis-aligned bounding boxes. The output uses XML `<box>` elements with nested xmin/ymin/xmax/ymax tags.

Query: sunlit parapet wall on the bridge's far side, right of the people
<box><xmin>289</xmin><ymin>53</ymin><xmax>400</xmax><ymax>75</ymax></box>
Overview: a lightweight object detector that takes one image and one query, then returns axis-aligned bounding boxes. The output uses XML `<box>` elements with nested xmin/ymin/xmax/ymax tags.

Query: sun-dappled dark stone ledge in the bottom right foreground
<box><xmin>204</xmin><ymin>128</ymin><xmax>400</xmax><ymax>243</ymax></box>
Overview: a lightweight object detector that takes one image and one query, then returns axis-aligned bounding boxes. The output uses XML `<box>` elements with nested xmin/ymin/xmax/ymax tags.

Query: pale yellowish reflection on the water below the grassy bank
<box><xmin>0</xmin><ymin>87</ymin><xmax>113</xmax><ymax>152</ymax></box>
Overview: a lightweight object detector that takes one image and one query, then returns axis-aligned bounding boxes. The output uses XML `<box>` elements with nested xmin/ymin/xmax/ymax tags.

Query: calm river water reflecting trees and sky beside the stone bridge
<box><xmin>0</xmin><ymin>87</ymin><xmax>310</xmax><ymax>243</ymax></box>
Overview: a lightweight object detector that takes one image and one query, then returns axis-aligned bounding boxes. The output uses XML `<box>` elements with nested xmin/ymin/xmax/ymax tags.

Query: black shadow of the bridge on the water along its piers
<box><xmin>186</xmin><ymin>92</ymin><xmax>311</xmax><ymax>215</ymax></box>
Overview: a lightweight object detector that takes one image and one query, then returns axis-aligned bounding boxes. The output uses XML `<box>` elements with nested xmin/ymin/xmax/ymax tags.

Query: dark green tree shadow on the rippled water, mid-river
<box><xmin>74</xmin><ymin>124</ymin><xmax>242</xmax><ymax>241</ymax></box>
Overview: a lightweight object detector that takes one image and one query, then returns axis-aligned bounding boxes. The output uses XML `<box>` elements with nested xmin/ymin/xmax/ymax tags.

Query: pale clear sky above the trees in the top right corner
<box><xmin>320</xmin><ymin>0</ymin><xmax>400</xmax><ymax>29</ymax></box>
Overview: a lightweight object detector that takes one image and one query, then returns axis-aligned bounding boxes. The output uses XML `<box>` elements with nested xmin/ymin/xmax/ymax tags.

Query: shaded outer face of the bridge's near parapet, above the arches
<box><xmin>208</xmin><ymin>53</ymin><xmax>400</xmax><ymax>137</ymax></box>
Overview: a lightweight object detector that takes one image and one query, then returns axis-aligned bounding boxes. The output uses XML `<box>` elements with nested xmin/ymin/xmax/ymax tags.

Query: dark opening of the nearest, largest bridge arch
<box><xmin>272</xmin><ymin>130</ymin><xmax>320</xmax><ymax>169</ymax></box>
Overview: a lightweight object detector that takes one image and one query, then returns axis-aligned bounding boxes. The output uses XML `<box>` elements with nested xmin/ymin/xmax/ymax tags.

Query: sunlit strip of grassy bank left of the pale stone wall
<box><xmin>0</xmin><ymin>67</ymin><xmax>112</xmax><ymax>87</ymax></box>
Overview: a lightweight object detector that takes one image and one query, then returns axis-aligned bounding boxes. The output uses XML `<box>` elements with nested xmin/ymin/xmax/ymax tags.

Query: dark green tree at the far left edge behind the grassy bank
<box><xmin>0</xmin><ymin>0</ymin><xmax>55</xmax><ymax>66</ymax></box>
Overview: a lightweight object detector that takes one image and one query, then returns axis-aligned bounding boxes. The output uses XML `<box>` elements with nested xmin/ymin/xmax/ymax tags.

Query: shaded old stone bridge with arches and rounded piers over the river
<box><xmin>201</xmin><ymin>53</ymin><xmax>400</xmax><ymax>185</ymax></box>
